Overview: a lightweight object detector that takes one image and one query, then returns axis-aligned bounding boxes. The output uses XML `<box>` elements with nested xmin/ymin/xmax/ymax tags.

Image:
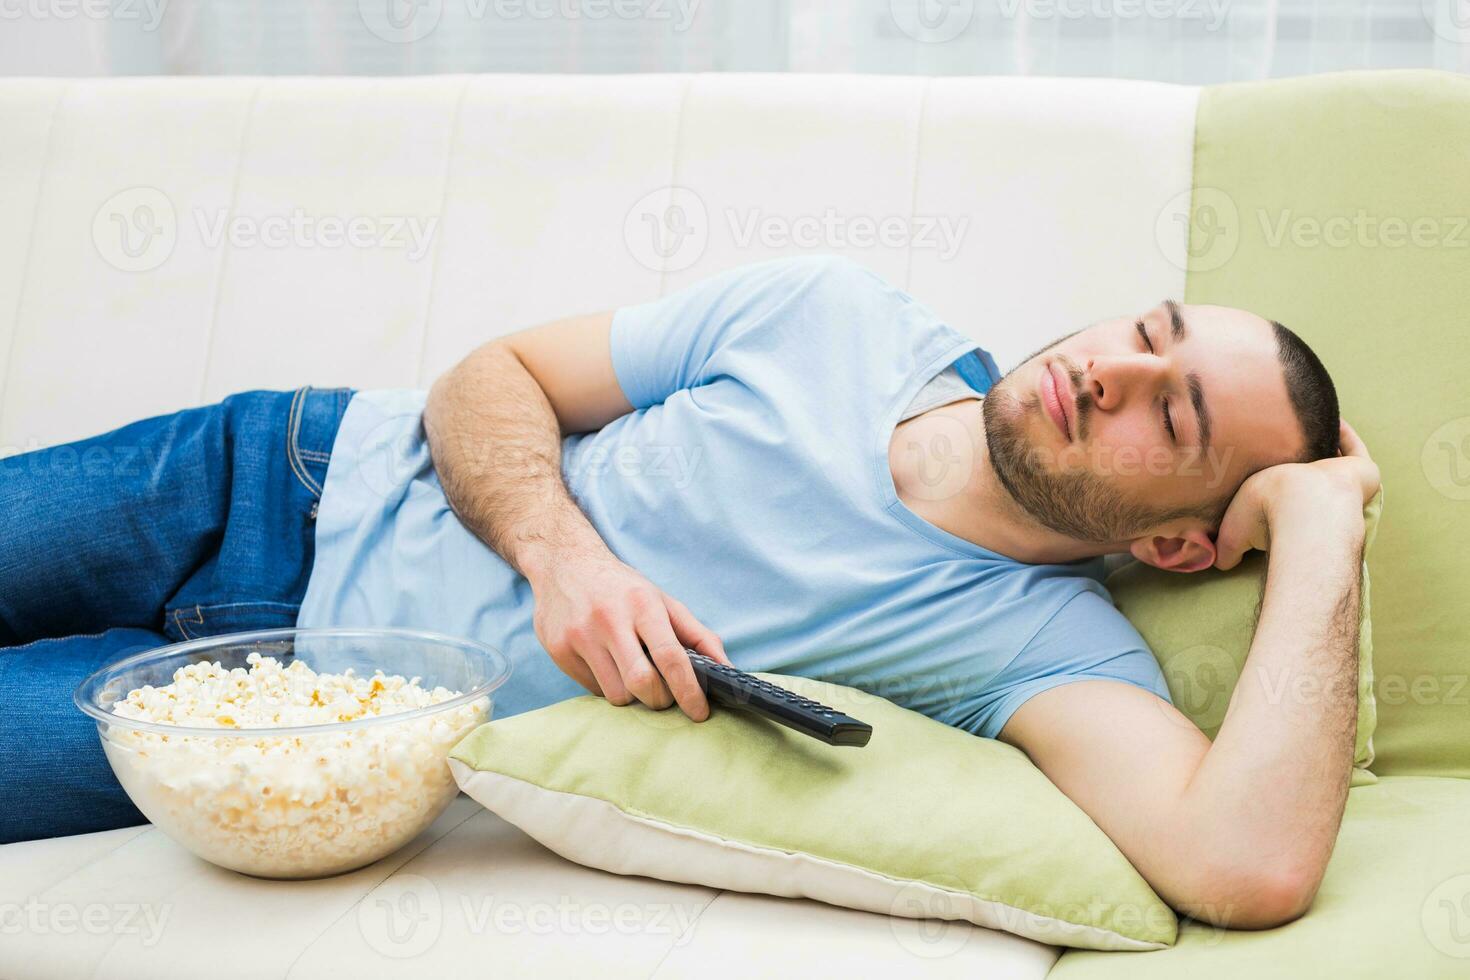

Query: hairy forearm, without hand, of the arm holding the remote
<box><xmin>423</xmin><ymin>342</ymin><xmax>607</xmax><ymax>582</ymax></box>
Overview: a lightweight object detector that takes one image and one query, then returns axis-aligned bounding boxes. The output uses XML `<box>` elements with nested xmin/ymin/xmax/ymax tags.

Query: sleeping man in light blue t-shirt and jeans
<box><xmin>0</xmin><ymin>252</ymin><xmax>1377</xmax><ymax>927</ymax></box>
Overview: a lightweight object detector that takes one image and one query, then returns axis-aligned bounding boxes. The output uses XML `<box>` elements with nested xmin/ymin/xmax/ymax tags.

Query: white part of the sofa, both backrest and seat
<box><xmin>0</xmin><ymin>75</ymin><xmax>1198</xmax><ymax>980</ymax></box>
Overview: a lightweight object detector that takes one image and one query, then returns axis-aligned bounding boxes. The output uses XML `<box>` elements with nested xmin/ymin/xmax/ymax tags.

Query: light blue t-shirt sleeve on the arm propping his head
<box><xmin>963</xmin><ymin>591</ymin><xmax>1169</xmax><ymax>738</ymax></box>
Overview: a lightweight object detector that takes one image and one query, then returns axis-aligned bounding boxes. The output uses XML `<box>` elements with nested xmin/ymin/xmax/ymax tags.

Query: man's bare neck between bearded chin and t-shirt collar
<box><xmin>891</xmin><ymin>398</ymin><xmax>1127</xmax><ymax>564</ymax></box>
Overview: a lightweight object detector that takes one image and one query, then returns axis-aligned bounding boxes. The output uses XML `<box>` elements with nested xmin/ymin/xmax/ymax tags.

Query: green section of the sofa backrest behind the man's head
<box><xmin>1187</xmin><ymin>72</ymin><xmax>1470</xmax><ymax>776</ymax></box>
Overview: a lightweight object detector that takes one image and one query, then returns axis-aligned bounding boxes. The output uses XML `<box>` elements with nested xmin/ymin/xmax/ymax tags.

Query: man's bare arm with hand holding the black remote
<box><xmin>423</xmin><ymin>313</ymin><xmax>728</xmax><ymax>720</ymax></box>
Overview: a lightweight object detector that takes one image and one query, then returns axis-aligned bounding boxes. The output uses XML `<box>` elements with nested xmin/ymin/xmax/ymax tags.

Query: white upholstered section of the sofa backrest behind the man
<box><xmin>0</xmin><ymin>75</ymin><xmax>1197</xmax><ymax>451</ymax></box>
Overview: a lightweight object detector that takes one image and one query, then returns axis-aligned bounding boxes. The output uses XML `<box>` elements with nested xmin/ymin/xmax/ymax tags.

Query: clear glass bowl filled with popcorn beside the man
<box><xmin>74</xmin><ymin>629</ymin><xmax>510</xmax><ymax>879</ymax></box>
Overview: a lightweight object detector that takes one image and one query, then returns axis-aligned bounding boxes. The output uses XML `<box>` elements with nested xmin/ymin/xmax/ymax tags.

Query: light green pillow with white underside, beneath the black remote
<box><xmin>450</xmin><ymin>674</ymin><xmax>1177</xmax><ymax>949</ymax></box>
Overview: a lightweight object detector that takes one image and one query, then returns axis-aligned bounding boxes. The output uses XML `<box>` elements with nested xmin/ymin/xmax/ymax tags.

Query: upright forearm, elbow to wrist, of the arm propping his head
<box><xmin>1179</xmin><ymin>510</ymin><xmax>1363</xmax><ymax>924</ymax></box>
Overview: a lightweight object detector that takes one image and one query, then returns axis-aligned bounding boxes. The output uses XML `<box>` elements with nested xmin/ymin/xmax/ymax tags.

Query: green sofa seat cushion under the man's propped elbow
<box><xmin>1050</xmin><ymin>776</ymin><xmax>1470</xmax><ymax>980</ymax></box>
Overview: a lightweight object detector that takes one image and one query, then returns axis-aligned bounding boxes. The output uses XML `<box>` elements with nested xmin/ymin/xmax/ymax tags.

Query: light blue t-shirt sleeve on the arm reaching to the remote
<box><xmin>612</xmin><ymin>256</ymin><xmax>878</xmax><ymax>408</ymax></box>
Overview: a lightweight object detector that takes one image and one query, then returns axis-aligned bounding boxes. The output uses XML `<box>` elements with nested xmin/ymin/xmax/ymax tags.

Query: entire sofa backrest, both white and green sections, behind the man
<box><xmin>0</xmin><ymin>67</ymin><xmax>1470</xmax><ymax>774</ymax></box>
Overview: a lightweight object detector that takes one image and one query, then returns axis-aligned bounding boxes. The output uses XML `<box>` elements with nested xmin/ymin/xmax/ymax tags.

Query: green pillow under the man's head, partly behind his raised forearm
<box><xmin>1107</xmin><ymin>491</ymin><xmax>1383</xmax><ymax>786</ymax></box>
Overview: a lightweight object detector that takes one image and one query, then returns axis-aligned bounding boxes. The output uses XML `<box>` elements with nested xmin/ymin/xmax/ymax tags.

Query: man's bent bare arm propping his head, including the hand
<box><xmin>1001</xmin><ymin>430</ymin><xmax>1377</xmax><ymax>929</ymax></box>
